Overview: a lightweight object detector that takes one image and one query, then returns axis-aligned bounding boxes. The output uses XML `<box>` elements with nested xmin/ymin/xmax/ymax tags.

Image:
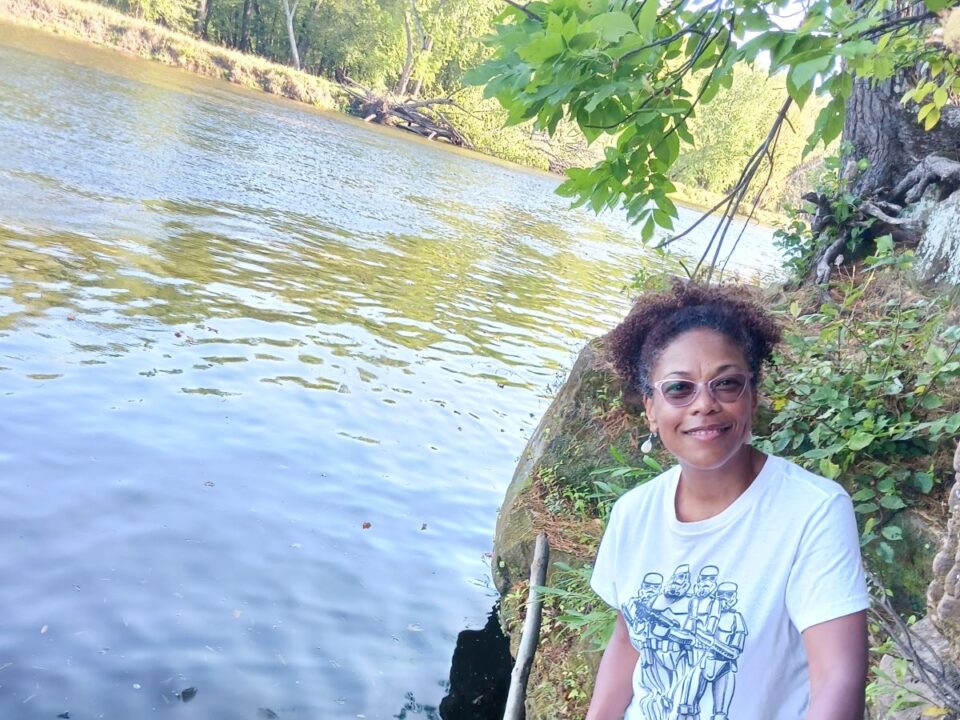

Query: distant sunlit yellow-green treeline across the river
<box><xmin>88</xmin><ymin>0</ymin><xmax>821</xmax><ymax>210</ymax></box>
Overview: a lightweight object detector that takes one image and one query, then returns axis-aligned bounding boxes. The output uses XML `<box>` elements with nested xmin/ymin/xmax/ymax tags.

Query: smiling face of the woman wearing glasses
<box><xmin>644</xmin><ymin>328</ymin><xmax>757</xmax><ymax>470</ymax></box>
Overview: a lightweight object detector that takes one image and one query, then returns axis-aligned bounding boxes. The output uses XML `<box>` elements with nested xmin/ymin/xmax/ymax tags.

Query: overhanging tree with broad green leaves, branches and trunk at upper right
<box><xmin>470</xmin><ymin>0</ymin><xmax>960</xmax><ymax>278</ymax></box>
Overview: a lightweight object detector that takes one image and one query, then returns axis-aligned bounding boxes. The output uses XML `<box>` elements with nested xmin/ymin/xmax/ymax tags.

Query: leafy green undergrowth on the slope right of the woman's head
<box><xmin>760</xmin><ymin>250</ymin><xmax>960</xmax><ymax>562</ymax></box>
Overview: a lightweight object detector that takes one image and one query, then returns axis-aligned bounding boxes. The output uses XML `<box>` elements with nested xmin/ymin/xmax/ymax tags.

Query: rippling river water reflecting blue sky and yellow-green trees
<box><xmin>0</xmin><ymin>24</ymin><xmax>770</xmax><ymax>720</ymax></box>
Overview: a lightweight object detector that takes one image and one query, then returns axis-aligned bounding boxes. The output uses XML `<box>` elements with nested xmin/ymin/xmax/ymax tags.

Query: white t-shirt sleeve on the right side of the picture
<box><xmin>786</xmin><ymin>493</ymin><xmax>870</xmax><ymax>632</ymax></box>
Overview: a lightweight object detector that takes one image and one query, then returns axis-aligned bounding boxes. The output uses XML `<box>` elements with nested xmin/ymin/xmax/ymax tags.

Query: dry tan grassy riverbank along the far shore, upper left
<box><xmin>0</xmin><ymin>0</ymin><xmax>347</xmax><ymax>110</ymax></box>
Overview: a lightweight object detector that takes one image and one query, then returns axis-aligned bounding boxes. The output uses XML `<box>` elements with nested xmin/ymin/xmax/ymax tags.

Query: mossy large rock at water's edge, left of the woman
<box><xmin>493</xmin><ymin>339</ymin><xmax>646</xmax><ymax>720</ymax></box>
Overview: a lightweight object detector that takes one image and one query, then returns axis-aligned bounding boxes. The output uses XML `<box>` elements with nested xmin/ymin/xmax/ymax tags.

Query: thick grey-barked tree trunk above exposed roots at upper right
<box><xmin>843</xmin><ymin>80</ymin><xmax>960</xmax><ymax>199</ymax></box>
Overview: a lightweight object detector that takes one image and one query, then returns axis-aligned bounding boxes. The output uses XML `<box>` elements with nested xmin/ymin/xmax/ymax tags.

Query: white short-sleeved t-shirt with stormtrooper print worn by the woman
<box><xmin>591</xmin><ymin>456</ymin><xmax>870</xmax><ymax>720</ymax></box>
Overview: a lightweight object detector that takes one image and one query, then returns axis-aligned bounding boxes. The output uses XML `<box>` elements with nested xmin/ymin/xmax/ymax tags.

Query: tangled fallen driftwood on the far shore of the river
<box><xmin>338</xmin><ymin>76</ymin><xmax>473</xmax><ymax>148</ymax></box>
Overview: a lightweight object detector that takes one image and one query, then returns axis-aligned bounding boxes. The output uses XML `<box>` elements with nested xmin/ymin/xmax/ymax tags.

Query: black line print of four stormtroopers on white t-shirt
<box><xmin>621</xmin><ymin>564</ymin><xmax>748</xmax><ymax>720</ymax></box>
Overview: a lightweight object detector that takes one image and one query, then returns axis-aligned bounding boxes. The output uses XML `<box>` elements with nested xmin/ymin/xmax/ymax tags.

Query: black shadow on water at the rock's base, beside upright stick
<box><xmin>394</xmin><ymin>605</ymin><xmax>513</xmax><ymax>720</ymax></box>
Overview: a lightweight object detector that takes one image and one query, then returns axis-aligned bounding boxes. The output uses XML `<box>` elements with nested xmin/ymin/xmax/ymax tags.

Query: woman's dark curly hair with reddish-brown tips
<box><xmin>606</xmin><ymin>280</ymin><xmax>780</xmax><ymax>396</ymax></box>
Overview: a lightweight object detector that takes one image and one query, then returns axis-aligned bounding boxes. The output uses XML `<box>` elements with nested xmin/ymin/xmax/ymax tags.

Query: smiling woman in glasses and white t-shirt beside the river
<box><xmin>587</xmin><ymin>284</ymin><xmax>869</xmax><ymax>720</ymax></box>
